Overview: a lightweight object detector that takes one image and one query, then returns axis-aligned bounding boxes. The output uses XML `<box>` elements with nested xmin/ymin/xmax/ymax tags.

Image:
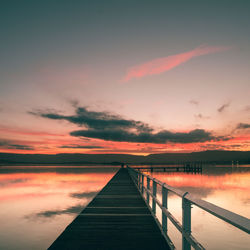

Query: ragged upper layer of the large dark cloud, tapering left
<box><xmin>29</xmin><ymin>107</ymin><xmax>152</xmax><ymax>132</ymax></box>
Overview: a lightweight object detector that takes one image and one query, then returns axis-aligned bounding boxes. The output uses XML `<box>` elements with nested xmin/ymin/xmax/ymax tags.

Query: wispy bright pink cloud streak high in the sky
<box><xmin>122</xmin><ymin>45</ymin><xmax>230</xmax><ymax>82</ymax></box>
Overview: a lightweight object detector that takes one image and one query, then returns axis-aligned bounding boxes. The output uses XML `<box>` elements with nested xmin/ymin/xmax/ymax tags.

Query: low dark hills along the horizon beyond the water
<box><xmin>0</xmin><ymin>150</ymin><xmax>250</xmax><ymax>165</ymax></box>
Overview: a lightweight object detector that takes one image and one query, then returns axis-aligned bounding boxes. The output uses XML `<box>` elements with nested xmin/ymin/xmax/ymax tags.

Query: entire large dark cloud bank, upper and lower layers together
<box><xmin>32</xmin><ymin>107</ymin><xmax>229</xmax><ymax>145</ymax></box>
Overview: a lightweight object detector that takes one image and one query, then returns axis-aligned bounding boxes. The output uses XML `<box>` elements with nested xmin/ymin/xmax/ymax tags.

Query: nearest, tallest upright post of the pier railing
<box><xmin>182</xmin><ymin>192</ymin><xmax>191</xmax><ymax>250</ymax></box>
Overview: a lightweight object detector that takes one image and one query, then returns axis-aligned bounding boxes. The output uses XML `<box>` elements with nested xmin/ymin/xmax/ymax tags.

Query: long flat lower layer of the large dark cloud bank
<box><xmin>70</xmin><ymin>129</ymin><xmax>225</xmax><ymax>143</ymax></box>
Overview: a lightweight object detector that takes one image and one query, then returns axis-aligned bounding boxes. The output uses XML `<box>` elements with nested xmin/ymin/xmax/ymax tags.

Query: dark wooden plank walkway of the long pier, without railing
<box><xmin>49</xmin><ymin>168</ymin><xmax>169</xmax><ymax>250</ymax></box>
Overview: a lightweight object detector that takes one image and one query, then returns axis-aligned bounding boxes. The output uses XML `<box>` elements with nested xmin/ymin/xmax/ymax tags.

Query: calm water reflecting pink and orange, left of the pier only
<box><xmin>0</xmin><ymin>166</ymin><xmax>117</xmax><ymax>250</ymax></box>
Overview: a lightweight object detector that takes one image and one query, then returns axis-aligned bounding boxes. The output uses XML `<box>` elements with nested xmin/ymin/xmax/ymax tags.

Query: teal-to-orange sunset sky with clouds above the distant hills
<box><xmin>0</xmin><ymin>0</ymin><xmax>250</xmax><ymax>155</ymax></box>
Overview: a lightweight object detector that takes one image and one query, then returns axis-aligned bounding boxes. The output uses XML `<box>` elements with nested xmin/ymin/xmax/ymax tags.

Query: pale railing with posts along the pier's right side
<box><xmin>128</xmin><ymin>167</ymin><xmax>250</xmax><ymax>250</ymax></box>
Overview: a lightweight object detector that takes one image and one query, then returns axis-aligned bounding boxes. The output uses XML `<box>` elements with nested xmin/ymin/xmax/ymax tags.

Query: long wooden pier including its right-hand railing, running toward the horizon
<box><xmin>49</xmin><ymin>167</ymin><xmax>250</xmax><ymax>250</ymax></box>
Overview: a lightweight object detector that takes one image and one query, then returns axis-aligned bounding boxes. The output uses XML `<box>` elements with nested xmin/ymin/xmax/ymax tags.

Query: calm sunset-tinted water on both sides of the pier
<box><xmin>0</xmin><ymin>166</ymin><xmax>250</xmax><ymax>250</ymax></box>
